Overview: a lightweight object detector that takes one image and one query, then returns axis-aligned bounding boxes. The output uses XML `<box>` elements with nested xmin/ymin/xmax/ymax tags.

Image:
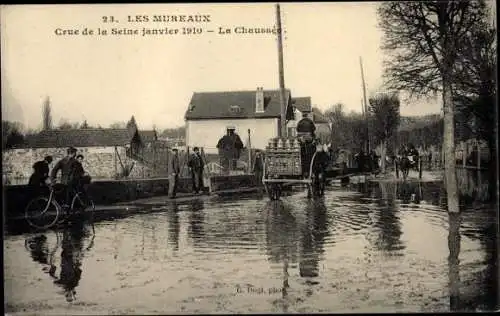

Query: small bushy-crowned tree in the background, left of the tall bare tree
<box><xmin>368</xmin><ymin>93</ymin><xmax>400</xmax><ymax>172</ymax></box>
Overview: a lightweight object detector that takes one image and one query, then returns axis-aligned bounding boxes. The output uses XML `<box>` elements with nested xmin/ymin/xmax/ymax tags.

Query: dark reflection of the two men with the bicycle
<box><xmin>25</xmin><ymin>221</ymin><xmax>95</xmax><ymax>302</ymax></box>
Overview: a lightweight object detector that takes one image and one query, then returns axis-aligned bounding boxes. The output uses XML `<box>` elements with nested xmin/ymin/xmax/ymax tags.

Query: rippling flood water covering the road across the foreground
<box><xmin>4</xmin><ymin>170</ymin><xmax>498</xmax><ymax>315</ymax></box>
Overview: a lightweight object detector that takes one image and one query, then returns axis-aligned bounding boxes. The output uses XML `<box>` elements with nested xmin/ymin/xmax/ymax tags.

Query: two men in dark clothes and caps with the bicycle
<box><xmin>29</xmin><ymin>147</ymin><xmax>90</xmax><ymax>208</ymax></box>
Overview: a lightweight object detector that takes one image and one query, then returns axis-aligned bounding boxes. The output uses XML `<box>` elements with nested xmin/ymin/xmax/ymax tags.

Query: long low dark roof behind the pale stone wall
<box><xmin>26</xmin><ymin>128</ymin><xmax>133</xmax><ymax>148</ymax></box>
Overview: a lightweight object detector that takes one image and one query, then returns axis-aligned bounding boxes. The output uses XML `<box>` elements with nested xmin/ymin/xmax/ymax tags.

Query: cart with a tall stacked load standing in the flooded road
<box><xmin>262</xmin><ymin>137</ymin><xmax>316</xmax><ymax>200</ymax></box>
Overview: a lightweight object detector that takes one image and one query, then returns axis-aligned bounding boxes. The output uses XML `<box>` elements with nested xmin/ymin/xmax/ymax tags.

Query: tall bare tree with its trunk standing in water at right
<box><xmin>378</xmin><ymin>1</ymin><xmax>486</xmax><ymax>212</ymax></box>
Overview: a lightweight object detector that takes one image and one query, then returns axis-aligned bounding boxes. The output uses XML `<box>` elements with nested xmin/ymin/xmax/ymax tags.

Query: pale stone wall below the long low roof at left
<box><xmin>2</xmin><ymin>147</ymin><xmax>152</xmax><ymax>184</ymax></box>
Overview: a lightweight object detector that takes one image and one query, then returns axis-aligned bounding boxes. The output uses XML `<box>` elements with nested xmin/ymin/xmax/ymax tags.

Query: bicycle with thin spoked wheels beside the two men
<box><xmin>25</xmin><ymin>186</ymin><xmax>95</xmax><ymax>229</ymax></box>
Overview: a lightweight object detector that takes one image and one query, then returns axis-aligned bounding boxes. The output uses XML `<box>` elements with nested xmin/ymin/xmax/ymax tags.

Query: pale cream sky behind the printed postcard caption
<box><xmin>0</xmin><ymin>2</ymin><xmax>440</xmax><ymax>129</ymax></box>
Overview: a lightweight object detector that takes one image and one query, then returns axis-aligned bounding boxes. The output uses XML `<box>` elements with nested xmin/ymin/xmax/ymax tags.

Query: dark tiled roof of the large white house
<box><xmin>185</xmin><ymin>89</ymin><xmax>293</xmax><ymax>120</ymax></box>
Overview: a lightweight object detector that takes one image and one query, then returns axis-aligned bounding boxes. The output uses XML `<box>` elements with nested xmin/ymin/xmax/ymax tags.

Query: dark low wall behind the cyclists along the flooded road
<box><xmin>3</xmin><ymin>178</ymin><xmax>191</xmax><ymax>216</ymax></box>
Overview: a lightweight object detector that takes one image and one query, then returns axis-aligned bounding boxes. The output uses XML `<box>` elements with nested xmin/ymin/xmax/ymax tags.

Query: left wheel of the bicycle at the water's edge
<box><xmin>25</xmin><ymin>196</ymin><xmax>59</xmax><ymax>229</ymax></box>
